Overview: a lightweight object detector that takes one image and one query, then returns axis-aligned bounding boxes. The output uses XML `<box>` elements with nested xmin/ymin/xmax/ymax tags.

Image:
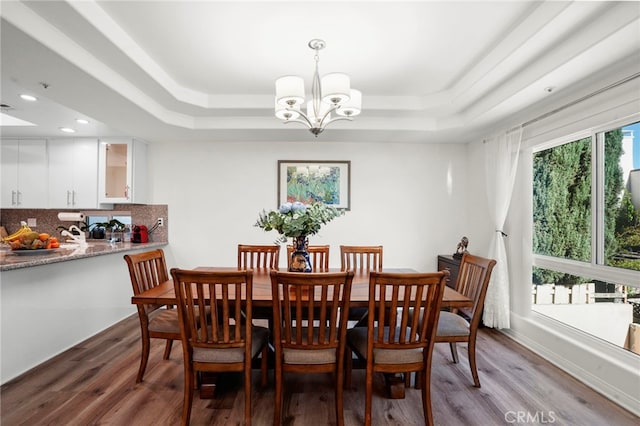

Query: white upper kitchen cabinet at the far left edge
<box><xmin>0</xmin><ymin>139</ymin><xmax>48</xmax><ymax>208</ymax></box>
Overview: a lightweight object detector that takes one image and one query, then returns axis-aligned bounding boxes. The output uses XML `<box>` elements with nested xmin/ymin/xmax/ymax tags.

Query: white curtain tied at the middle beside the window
<box><xmin>482</xmin><ymin>127</ymin><xmax>522</xmax><ymax>328</ymax></box>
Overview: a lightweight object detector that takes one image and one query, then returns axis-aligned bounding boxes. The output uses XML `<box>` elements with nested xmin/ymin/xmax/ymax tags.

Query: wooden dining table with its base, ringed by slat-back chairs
<box><xmin>131</xmin><ymin>266</ymin><xmax>473</xmax><ymax>399</ymax></box>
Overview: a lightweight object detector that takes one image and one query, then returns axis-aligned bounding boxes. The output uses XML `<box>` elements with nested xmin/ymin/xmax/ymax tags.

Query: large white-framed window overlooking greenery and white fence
<box><xmin>532</xmin><ymin>123</ymin><xmax>640</xmax><ymax>347</ymax></box>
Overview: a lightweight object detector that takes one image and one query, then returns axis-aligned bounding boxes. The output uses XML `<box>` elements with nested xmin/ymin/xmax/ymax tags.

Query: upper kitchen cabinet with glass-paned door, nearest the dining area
<box><xmin>98</xmin><ymin>139</ymin><xmax>147</xmax><ymax>204</ymax></box>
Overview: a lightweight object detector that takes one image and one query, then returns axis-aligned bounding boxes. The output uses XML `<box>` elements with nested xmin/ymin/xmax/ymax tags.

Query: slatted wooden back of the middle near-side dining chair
<box><xmin>271</xmin><ymin>271</ymin><xmax>353</xmax><ymax>356</ymax></box>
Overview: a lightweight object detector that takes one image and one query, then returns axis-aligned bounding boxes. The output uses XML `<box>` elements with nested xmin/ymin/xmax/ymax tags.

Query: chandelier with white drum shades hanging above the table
<box><xmin>275</xmin><ymin>39</ymin><xmax>362</xmax><ymax>137</ymax></box>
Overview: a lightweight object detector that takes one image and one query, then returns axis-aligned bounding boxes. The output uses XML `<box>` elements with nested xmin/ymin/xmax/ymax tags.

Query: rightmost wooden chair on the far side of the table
<box><xmin>340</xmin><ymin>245</ymin><xmax>383</xmax><ymax>327</ymax></box>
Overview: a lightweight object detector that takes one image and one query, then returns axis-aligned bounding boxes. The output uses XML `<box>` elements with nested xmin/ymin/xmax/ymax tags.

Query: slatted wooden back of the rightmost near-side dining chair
<box><xmin>368</xmin><ymin>271</ymin><xmax>449</xmax><ymax>356</ymax></box>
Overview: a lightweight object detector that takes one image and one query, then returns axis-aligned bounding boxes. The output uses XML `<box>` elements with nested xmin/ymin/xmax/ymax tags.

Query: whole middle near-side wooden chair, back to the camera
<box><xmin>271</xmin><ymin>271</ymin><xmax>353</xmax><ymax>426</ymax></box>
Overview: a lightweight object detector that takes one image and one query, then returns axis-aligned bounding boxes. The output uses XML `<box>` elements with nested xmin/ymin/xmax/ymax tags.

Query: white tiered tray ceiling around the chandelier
<box><xmin>0</xmin><ymin>0</ymin><xmax>640</xmax><ymax>143</ymax></box>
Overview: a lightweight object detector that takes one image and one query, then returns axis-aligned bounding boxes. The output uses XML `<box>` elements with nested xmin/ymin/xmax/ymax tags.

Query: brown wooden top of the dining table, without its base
<box><xmin>131</xmin><ymin>266</ymin><xmax>473</xmax><ymax>308</ymax></box>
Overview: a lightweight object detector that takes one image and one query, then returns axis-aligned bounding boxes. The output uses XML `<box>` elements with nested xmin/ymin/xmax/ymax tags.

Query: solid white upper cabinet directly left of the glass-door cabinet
<box><xmin>48</xmin><ymin>139</ymin><xmax>98</xmax><ymax>208</ymax></box>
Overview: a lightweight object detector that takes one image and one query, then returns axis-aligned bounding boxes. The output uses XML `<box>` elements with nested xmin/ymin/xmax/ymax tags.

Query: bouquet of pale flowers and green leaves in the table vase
<box><xmin>255</xmin><ymin>202</ymin><xmax>344</xmax><ymax>243</ymax></box>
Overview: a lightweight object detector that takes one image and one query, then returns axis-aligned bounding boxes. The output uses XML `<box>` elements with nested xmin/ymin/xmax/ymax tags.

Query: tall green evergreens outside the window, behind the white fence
<box><xmin>533</xmin><ymin>129</ymin><xmax>628</xmax><ymax>284</ymax></box>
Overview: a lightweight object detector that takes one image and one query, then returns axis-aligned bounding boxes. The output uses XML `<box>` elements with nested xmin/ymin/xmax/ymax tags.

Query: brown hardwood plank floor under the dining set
<box><xmin>0</xmin><ymin>316</ymin><xmax>640</xmax><ymax>426</ymax></box>
